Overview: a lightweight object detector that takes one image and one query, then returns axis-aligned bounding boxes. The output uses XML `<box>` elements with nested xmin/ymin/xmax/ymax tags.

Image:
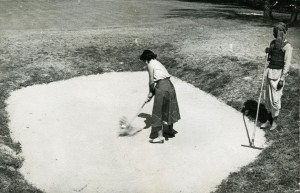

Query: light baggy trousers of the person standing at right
<box><xmin>265</xmin><ymin>78</ymin><xmax>283</xmax><ymax>118</ymax></box>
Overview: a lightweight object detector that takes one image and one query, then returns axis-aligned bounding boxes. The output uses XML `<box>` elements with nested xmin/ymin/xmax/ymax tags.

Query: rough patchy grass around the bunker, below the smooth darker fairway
<box><xmin>0</xmin><ymin>0</ymin><xmax>300</xmax><ymax>193</ymax></box>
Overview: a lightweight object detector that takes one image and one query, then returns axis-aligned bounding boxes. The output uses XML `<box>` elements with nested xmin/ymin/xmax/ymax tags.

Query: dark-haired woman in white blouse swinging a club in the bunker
<box><xmin>140</xmin><ymin>50</ymin><xmax>180</xmax><ymax>143</ymax></box>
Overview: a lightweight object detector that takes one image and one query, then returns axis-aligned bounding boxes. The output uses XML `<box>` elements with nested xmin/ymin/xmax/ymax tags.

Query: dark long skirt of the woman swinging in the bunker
<box><xmin>152</xmin><ymin>78</ymin><xmax>180</xmax><ymax>127</ymax></box>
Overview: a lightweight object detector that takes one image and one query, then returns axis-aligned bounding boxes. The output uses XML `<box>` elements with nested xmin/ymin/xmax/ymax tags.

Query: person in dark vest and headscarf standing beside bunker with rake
<box><xmin>261</xmin><ymin>22</ymin><xmax>293</xmax><ymax>130</ymax></box>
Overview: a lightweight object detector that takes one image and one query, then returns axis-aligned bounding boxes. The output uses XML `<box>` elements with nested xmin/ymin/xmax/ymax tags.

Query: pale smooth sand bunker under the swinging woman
<box><xmin>7</xmin><ymin>72</ymin><xmax>265</xmax><ymax>193</ymax></box>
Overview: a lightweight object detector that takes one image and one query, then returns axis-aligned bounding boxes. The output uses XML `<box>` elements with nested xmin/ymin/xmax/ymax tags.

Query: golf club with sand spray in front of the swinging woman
<box><xmin>119</xmin><ymin>102</ymin><xmax>147</xmax><ymax>136</ymax></box>
